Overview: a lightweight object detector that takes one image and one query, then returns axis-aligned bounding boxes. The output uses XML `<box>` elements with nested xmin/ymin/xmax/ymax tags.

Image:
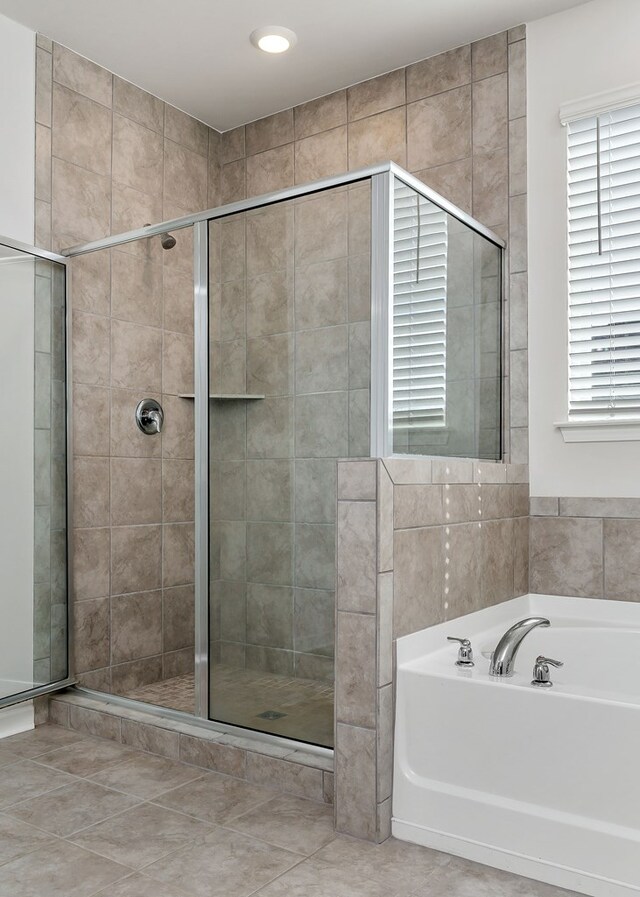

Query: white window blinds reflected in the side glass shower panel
<box><xmin>393</xmin><ymin>181</ymin><xmax>447</xmax><ymax>429</ymax></box>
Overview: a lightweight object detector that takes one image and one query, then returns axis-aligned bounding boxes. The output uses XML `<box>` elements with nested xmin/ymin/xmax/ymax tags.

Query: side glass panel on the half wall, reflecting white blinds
<box><xmin>390</xmin><ymin>178</ymin><xmax>502</xmax><ymax>460</ymax></box>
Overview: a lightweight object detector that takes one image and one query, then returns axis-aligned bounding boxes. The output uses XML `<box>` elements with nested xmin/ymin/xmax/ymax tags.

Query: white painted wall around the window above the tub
<box><xmin>527</xmin><ymin>0</ymin><xmax>640</xmax><ymax>497</ymax></box>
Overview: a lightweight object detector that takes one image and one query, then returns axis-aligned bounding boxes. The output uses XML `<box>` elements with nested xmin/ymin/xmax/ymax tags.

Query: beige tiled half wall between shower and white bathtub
<box><xmin>335</xmin><ymin>459</ymin><xmax>529</xmax><ymax>841</ymax></box>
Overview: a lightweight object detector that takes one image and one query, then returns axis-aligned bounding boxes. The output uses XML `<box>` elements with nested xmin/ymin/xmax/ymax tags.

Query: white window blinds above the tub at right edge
<box><xmin>568</xmin><ymin>104</ymin><xmax>640</xmax><ymax>419</ymax></box>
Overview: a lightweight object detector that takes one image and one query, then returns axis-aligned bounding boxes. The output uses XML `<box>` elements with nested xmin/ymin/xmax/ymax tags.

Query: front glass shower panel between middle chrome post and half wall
<box><xmin>209</xmin><ymin>181</ymin><xmax>371</xmax><ymax>746</ymax></box>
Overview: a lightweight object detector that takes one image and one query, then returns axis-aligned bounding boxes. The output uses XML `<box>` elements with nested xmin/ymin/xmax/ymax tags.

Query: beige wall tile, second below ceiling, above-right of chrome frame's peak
<box><xmin>407</xmin><ymin>86</ymin><xmax>471</xmax><ymax>171</ymax></box>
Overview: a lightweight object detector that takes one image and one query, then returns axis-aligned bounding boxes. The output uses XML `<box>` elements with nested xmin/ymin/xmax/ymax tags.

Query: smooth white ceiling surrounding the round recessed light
<box><xmin>0</xmin><ymin>0</ymin><xmax>587</xmax><ymax>131</ymax></box>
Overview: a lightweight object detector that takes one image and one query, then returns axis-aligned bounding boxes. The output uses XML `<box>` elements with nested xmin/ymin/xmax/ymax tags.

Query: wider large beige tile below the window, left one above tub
<box><xmin>529</xmin><ymin>517</ymin><xmax>603</xmax><ymax>598</ymax></box>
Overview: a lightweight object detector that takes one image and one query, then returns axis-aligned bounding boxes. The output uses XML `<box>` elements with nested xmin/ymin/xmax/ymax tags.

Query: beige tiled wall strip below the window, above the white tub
<box><xmin>530</xmin><ymin>497</ymin><xmax>640</xmax><ymax>601</ymax></box>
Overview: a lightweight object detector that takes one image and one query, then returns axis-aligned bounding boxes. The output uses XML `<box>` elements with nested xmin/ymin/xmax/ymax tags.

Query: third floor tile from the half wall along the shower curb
<box><xmin>91</xmin><ymin>753</ymin><xmax>202</xmax><ymax>800</ymax></box>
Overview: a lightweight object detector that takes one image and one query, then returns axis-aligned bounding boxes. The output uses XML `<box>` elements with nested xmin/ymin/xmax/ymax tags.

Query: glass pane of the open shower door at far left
<box><xmin>0</xmin><ymin>245</ymin><xmax>69</xmax><ymax>704</ymax></box>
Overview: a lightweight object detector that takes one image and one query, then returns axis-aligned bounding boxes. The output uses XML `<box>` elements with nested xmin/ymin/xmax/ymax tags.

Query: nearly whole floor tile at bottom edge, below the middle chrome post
<box><xmin>145</xmin><ymin>828</ymin><xmax>300</xmax><ymax>897</ymax></box>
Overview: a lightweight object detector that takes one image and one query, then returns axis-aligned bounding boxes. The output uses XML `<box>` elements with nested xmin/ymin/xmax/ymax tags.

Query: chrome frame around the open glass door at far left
<box><xmin>0</xmin><ymin>236</ymin><xmax>76</xmax><ymax>708</ymax></box>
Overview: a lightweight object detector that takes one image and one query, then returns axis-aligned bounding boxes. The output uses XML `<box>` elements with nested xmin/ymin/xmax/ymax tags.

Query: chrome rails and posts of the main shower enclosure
<box><xmin>60</xmin><ymin>162</ymin><xmax>505</xmax><ymax>755</ymax></box>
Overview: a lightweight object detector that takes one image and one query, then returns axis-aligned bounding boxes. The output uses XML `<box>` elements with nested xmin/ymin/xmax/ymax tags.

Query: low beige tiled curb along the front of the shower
<box><xmin>49</xmin><ymin>690</ymin><xmax>333</xmax><ymax>804</ymax></box>
